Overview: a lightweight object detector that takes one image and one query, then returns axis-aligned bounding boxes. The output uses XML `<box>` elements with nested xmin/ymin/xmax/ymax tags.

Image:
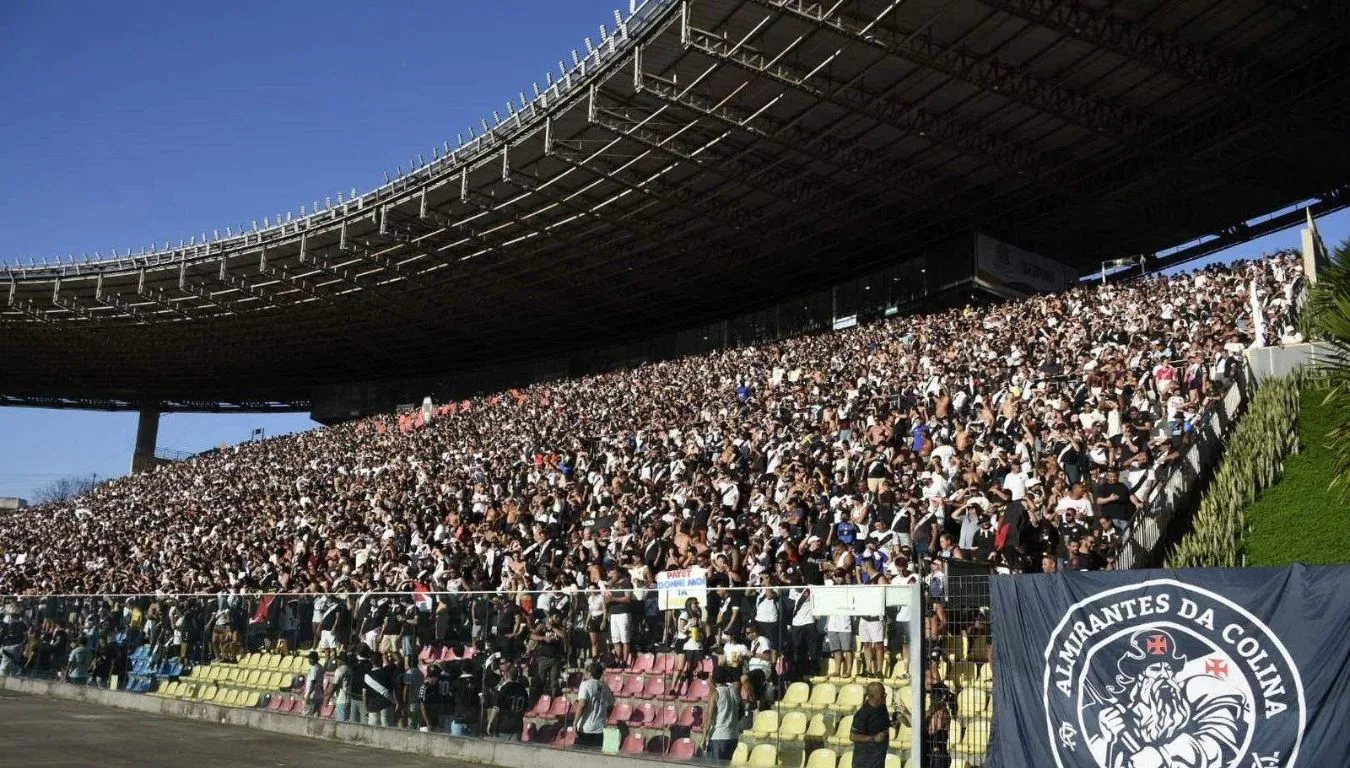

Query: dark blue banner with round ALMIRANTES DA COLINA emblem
<box><xmin>990</xmin><ymin>566</ymin><xmax>1350</xmax><ymax>768</ymax></box>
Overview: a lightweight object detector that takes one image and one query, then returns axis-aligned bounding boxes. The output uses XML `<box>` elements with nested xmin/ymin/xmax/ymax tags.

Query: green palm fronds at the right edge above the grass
<box><xmin>1307</xmin><ymin>239</ymin><xmax>1350</xmax><ymax>494</ymax></box>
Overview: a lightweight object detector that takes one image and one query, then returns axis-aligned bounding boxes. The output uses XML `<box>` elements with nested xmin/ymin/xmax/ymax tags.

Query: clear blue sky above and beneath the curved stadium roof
<box><xmin>0</xmin><ymin>0</ymin><xmax>1350</xmax><ymax>497</ymax></box>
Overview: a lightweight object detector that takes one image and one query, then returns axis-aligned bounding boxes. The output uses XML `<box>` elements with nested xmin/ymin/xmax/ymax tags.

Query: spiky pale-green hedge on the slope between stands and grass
<box><xmin>1166</xmin><ymin>374</ymin><xmax>1304</xmax><ymax>568</ymax></box>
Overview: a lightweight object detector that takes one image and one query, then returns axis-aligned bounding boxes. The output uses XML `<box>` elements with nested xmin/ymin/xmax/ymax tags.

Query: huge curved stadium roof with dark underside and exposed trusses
<box><xmin>0</xmin><ymin>0</ymin><xmax>1350</xmax><ymax>410</ymax></box>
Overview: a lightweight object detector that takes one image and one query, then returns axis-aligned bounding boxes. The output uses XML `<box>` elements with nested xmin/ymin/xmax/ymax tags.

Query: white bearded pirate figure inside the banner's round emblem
<box><xmin>1084</xmin><ymin>628</ymin><xmax>1247</xmax><ymax>768</ymax></box>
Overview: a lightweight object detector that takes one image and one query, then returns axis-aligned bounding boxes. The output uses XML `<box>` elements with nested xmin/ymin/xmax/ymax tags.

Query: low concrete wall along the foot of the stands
<box><xmin>0</xmin><ymin>678</ymin><xmax>671</xmax><ymax>768</ymax></box>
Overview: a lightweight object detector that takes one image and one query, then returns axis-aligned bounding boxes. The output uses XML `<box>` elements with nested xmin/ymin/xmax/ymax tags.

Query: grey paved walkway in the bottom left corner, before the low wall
<box><xmin>0</xmin><ymin>691</ymin><xmax>469</xmax><ymax>768</ymax></box>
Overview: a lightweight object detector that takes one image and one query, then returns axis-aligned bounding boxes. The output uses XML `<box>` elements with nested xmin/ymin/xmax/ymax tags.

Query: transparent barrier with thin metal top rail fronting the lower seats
<box><xmin>0</xmin><ymin>583</ymin><xmax>923</xmax><ymax>765</ymax></box>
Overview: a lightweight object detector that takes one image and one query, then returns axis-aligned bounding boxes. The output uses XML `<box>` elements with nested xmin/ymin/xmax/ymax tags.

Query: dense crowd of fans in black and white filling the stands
<box><xmin>0</xmin><ymin>255</ymin><xmax>1301</xmax><ymax>750</ymax></box>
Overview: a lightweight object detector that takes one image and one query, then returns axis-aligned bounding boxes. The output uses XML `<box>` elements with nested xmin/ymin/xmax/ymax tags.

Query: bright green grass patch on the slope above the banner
<box><xmin>1246</xmin><ymin>389</ymin><xmax>1350</xmax><ymax>566</ymax></box>
